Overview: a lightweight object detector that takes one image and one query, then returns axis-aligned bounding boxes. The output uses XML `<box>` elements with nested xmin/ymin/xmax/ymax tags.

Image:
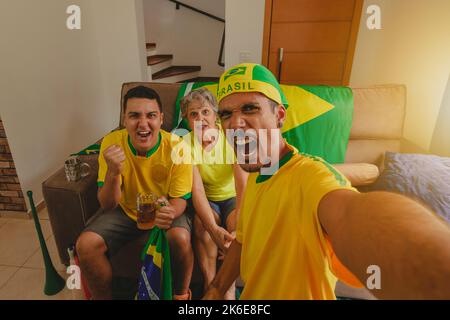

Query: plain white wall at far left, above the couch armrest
<box><xmin>0</xmin><ymin>0</ymin><xmax>146</xmax><ymax>210</ymax></box>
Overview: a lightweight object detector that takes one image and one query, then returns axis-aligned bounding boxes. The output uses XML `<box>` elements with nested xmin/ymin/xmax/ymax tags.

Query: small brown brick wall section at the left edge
<box><xmin>0</xmin><ymin>118</ymin><xmax>27</xmax><ymax>213</ymax></box>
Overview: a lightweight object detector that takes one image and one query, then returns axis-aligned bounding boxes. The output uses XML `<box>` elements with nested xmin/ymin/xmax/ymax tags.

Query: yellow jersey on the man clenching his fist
<box><xmin>97</xmin><ymin>129</ymin><xmax>192</xmax><ymax>220</ymax></box>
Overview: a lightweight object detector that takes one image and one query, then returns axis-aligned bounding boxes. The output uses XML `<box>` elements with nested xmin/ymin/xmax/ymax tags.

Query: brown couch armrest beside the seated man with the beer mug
<box><xmin>42</xmin><ymin>155</ymin><xmax>100</xmax><ymax>265</ymax></box>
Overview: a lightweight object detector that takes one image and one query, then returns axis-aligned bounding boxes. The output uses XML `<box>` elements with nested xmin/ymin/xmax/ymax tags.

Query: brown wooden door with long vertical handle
<box><xmin>263</xmin><ymin>0</ymin><xmax>363</xmax><ymax>85</ymax></box>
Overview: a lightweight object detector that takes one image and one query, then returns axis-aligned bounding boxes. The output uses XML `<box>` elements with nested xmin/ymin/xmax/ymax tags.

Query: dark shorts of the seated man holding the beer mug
<box><xmin>84</xmin><ymin>204</ymin><xmax>193</xmax><ymax>257</ymax></box>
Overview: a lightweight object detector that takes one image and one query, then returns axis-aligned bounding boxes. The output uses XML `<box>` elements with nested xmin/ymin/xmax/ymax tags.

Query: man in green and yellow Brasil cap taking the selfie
<box><xmin>205</xmin><ymin>64</ymin><xmax>450</xmax><ymax>299</ymax></box>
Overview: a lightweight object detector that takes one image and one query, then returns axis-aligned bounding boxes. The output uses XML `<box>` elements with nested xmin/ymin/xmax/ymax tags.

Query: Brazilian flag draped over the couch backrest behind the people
<box><xmin>174</xmin><ymin>82</ymin><xmax>353</xmax><ymax>164</ymax></box>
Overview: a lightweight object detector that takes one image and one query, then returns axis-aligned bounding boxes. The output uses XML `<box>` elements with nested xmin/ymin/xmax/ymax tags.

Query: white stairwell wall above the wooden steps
<box><xmin>143</xmin><ymin>0</ymin><xmax>225</xmax><ymax>76</ymax></box>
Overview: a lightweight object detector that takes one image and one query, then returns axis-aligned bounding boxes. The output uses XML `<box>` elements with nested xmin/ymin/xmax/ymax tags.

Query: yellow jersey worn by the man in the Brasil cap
<box><xmin>236</xmin><ymin>146</ymin><xmax>359</xmax><ymax>300</ymax></box>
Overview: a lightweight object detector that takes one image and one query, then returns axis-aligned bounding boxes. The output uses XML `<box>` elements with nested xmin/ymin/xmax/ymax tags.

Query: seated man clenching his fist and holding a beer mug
<box><xmin>76</xmin><ymin>86</ymin><xmax>193</xmax><ymax>299</ymax></box>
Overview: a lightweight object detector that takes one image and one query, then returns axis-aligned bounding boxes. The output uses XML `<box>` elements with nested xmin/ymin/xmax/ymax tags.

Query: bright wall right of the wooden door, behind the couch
<box><xmin>350</xmin><ymin>0</ymin><xmax>450</xmax><ymax>150</ymax></box>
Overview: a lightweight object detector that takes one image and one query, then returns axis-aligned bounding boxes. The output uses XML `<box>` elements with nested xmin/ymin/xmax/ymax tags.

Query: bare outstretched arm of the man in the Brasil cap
<box><xmin>318</xmin><ymin>190</ymin><xmax>450</xmax><ymax>299</ymax></box>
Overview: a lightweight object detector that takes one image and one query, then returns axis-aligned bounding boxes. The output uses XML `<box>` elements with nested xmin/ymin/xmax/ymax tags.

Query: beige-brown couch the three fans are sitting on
<box><xmin>42</xmin><ymin>83</ymin><xmax>406</xmax><ymax>298</ymax></box>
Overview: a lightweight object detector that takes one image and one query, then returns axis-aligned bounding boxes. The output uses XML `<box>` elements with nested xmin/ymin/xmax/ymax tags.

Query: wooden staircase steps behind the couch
<box><xmin>146</xmin><ymin>43</ymin><xmax>209</xmax><ymax>83</ymax></box>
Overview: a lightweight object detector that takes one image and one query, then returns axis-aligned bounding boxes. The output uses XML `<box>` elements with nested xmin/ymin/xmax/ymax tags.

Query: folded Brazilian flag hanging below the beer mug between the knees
<box><xmin>136</xmin><ymin>227</ymin><xmax>172</xmax><ymax>300</ymax></box>
